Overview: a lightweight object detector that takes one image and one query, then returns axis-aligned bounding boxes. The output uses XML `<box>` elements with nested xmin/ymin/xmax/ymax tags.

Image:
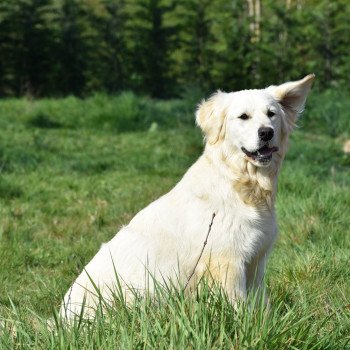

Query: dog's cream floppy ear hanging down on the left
<box><xmin>196</xmin><ymin>91</ymin><xmax>227</xmax><ymax>144</ymax></box>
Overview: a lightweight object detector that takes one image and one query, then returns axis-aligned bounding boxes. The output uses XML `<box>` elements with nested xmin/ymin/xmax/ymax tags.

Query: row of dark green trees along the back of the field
<box><xmin>0</xmin><ymin>0</ymin><xmax>350</xmax><ymax>98</ymax></box>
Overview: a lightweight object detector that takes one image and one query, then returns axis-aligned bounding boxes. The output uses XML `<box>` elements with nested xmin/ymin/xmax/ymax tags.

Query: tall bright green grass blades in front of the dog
<box><xmin>0</xmin><ymin>281</ymin><xmax>350</xmax><ymax>350</ymax></box>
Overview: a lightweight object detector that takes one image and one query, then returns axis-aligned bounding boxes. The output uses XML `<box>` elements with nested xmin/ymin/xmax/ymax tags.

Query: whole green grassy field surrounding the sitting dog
<box><xmin>0</xmin><ymin>92</ymin><xmax>350</xmax><ymax>350</ymax></box>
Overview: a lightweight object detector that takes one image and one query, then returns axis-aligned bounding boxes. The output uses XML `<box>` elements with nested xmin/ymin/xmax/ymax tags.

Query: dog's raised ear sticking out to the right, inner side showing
<box><xmin>267</xmin><ymin>74</ymin><xmax>315</xmax><ymax>122</ymax></box>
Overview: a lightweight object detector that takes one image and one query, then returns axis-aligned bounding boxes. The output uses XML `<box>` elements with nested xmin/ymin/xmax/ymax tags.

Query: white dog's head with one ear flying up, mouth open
<box><xmin>196</xmin><ymin>74</ymin><xmax>315</xmax><ymax>167</ymax></box>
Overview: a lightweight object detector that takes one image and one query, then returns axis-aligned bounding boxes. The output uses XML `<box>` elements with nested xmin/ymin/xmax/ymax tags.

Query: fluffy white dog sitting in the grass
<box><xmin>61</xmin><ymin>75</ymin><xmax>314</xmax><ymax>318</ymax></box>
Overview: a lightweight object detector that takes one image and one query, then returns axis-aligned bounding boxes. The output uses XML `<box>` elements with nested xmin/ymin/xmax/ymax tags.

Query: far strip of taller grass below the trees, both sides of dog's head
<box><xmin>0</xmin><ymin>90</ymin><xmax>350</xmax><ymax>137</ymax></box>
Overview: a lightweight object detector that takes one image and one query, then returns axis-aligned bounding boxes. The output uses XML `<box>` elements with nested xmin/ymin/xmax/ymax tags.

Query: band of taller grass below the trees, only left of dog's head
<box><xmin>1</xmin><ymin>92</ymin><xmax>195</xmax><ymax>132</ymax></box>
